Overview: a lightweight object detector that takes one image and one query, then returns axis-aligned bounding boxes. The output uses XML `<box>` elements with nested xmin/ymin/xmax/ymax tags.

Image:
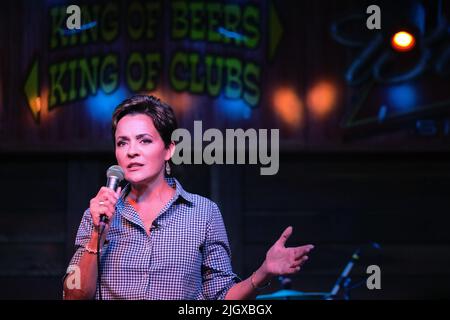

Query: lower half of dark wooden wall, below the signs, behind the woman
<box><xmin>0</xmin><ymin>153</ymin><xmax>450</xmax><ymax>299</ymax></box>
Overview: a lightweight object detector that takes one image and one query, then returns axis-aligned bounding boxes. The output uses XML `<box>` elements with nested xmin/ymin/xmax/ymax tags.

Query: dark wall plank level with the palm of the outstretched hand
<box><xmin>244</xmin><ymin>244</ymin><xmax>450</xmax><ymax>277</ymax></box>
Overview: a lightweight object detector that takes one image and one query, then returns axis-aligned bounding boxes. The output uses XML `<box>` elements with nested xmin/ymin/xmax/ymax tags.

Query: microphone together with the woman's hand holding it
<box><xmin>89</xmin><ymin>165</ymin><xmax>124</xmax><ymax>234</ymax></box>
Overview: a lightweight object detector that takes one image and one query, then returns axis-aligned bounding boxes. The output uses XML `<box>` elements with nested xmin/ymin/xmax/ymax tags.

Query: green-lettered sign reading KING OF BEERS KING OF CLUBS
<box><xmin>25</xmin><ymin>1</ymin><xmax>282</xmax><ymax>120</ymax></box>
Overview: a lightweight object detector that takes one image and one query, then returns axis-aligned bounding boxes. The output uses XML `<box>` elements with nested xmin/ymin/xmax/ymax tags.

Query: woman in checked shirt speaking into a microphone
<box><xmin>64</xmin><ymin>95</ymin><xmax>313</xmax><ymax>300</ymax></box>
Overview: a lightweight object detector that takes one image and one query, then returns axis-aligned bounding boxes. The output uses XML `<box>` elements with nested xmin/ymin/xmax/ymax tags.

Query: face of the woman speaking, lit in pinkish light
<box><xmin>115</xmin><ymin>114</ymin><xmax>174</xmax><ymax>184</ymax></box>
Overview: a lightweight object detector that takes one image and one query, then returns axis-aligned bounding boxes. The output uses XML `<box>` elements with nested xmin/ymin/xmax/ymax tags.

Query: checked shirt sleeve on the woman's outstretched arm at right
<box><xmin>202</xmin><ymin>203</ymin><xmax>240</xmax><ymax>300</ymax></box>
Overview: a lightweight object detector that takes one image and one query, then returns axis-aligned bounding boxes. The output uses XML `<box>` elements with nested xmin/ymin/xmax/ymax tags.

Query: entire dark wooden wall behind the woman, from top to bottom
<box><xmin>0</xmin><ymin>0</ymin><xmax>450</xmax><ymax>299</ymax></box>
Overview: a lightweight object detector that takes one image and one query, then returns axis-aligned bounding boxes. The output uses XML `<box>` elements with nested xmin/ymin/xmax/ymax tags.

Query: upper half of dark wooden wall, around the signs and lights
<box><xmin>0</xmin><ymin>0</ymin><xmax>450</xmax><ymax>153</ymax></box>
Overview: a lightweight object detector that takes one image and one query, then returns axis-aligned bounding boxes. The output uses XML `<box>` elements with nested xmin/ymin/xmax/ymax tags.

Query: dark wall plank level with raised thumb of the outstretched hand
<box><xmin>244</xmin><ymin>213</ymin><xmax>450</xmax><ymax>244</ymax></box>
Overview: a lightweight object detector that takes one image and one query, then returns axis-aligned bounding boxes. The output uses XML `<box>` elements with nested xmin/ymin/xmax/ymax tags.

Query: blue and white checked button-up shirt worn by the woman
<box><xmin>66</xmin><ymin>178</ymin><xmax>240</xmax><ymax>300</ymax></box>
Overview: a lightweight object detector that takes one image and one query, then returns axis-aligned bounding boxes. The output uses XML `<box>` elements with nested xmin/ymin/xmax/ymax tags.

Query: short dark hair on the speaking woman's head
<box><xmin>112</xmin><ymin>94</ymin><xmax>178</xmax><ymax>148</ymax></box>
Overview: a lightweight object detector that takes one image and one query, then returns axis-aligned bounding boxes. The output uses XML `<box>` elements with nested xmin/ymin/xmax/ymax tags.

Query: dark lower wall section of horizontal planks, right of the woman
<box><xmin>239</xmin><ymin>153</ymin><xmax>450</xmax><ymax>299</ymax></box>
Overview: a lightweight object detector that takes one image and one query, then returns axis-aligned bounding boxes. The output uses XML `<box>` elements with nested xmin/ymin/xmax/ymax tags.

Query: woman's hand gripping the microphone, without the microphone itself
<box><xmin>89</xmin><ymin>187</ymin><xmax>122</xmax><ymax>234</ymax></box>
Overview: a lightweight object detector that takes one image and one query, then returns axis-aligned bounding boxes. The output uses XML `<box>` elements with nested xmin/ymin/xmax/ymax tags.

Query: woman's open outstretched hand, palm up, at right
<box><xmin>264</xmin><ymin>226</ymin><xmax>314</xmax><ymax>276</ymax></box>
